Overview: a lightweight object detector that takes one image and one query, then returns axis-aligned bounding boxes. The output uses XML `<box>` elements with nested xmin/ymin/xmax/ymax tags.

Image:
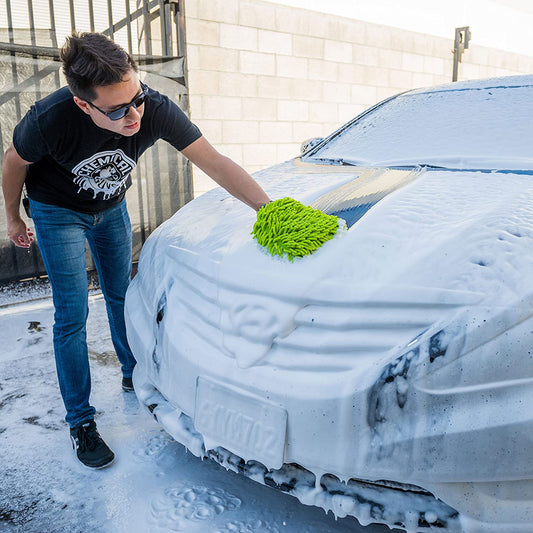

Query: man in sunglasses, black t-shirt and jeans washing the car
<box><xmin>2</xmin><ymin>33</ymin><xmax>269</xmax><ymax>468</ymax></box>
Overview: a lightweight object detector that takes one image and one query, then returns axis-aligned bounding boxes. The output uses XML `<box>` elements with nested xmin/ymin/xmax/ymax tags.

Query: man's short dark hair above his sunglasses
<box><xmin>59</xmin><ymin>33</ymin><xmax>137</xmax><ymax>102</ymax></box>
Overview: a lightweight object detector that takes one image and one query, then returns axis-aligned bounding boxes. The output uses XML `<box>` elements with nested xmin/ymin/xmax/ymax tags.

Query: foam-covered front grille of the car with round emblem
<box><xmin>162</xmin><ymin>247</ymin><xmax>479</xmax><ymax>371</ymax></box>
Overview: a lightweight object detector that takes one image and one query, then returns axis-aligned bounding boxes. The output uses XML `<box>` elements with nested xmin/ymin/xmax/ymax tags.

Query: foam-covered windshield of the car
<box><xmin>304</xmin><ymin>77</ymin><xmax>533</xmax><ymax>170</ymax></box>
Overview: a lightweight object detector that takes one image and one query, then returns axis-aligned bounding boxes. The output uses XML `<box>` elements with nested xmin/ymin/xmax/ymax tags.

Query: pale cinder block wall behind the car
<box><xmin>185</xmin><ymin>0</ymin><xmax>533</xmax><ymax>195</ymax></box>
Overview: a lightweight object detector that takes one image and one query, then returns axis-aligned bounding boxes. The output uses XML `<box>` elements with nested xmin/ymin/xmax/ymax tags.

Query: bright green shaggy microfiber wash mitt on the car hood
<box><xmin>252</xmin><ymin>198</ymin><xmax>339</xmax><ymax>261</ymax></box>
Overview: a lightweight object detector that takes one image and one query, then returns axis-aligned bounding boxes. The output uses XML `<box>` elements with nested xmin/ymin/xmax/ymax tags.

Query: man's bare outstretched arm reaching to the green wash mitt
<box><xmin>181</xmin><ymin>137</ymin><xmax>270</xmax><ymax>211</ymax></box>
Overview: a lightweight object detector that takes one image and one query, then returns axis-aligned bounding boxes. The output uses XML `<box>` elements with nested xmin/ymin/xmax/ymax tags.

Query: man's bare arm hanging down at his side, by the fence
<box><xmin>2</xmin><ymin>144</ymin><xmax>33</xmax><ymax>248</ymax></box>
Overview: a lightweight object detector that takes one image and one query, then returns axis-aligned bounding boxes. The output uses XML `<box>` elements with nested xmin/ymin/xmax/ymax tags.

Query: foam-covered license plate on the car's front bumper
<box><xmin>194</xmin><ymin>377</ymin><xmax>287</xmax><ymax>468</ymax></box>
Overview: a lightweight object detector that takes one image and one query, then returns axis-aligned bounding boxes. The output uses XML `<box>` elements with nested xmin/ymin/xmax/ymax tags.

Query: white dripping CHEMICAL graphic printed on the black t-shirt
<box><xmin>72</xmin><ymin>149</ymin><xmax>135</xmax><ymax>200</ymax></box>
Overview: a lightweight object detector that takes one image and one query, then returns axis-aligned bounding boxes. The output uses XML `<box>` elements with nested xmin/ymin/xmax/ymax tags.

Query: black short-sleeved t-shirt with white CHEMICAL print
<box><xmin>13</xmin><ymin>87</ymin><xmax>201</xmax><ymax>213</ymax></box>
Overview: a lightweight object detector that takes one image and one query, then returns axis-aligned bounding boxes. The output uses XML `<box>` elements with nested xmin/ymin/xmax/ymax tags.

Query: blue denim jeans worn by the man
<box><xmin>30</xmin><ymin>200</ymin><xmax>135</xmax><ymax>427</ymax></box>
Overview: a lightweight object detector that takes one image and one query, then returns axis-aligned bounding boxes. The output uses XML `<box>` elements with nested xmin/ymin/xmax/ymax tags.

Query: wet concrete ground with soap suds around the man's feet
<box><xmin>0</xmin><ymin>285</ymin><xmax>390</xmax><ymax>533</ymax></box>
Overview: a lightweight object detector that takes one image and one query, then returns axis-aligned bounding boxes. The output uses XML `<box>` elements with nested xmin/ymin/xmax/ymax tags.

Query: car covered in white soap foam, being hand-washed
<box><xmin>126</xmin><ymin>75</ymin><xmax>533</xmax><ymax>533</ymax></box>
